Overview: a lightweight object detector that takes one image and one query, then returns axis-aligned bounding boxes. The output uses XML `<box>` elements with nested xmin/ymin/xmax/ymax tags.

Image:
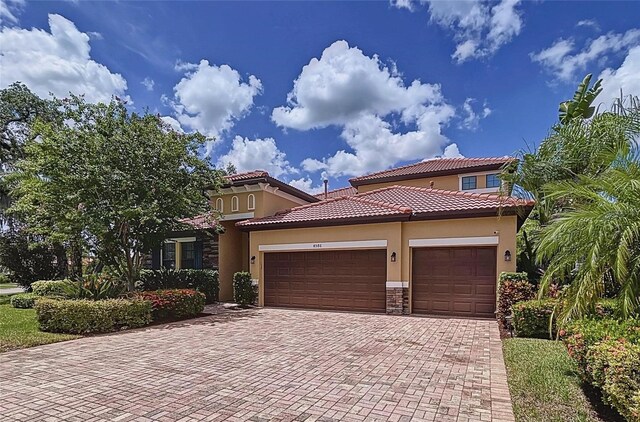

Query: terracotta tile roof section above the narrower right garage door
<box><xmin>358</xmin><ymin>185</ymin><xmax>534</xmax><ymax>214</ymax></box>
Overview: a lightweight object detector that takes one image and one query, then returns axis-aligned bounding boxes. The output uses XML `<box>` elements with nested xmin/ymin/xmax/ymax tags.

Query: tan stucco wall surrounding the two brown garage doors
<box><xmin>249</xmin><ymin>216</ymin><xmax>517</xmax><ymax>305</ymax></box>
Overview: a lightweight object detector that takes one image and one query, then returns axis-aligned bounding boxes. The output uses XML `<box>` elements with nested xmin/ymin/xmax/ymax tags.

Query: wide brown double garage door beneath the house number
<box><xmin>264</xmin><ymin>250</ymin><xmax>387</xmax><ymax>312</ymax></box>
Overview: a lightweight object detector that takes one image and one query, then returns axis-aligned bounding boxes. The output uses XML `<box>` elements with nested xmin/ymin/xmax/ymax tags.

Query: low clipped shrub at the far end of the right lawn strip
<box><xmin>512</xmin><ymin>299</ymin><xmax>558</xmax><ymax>338</ymax></box>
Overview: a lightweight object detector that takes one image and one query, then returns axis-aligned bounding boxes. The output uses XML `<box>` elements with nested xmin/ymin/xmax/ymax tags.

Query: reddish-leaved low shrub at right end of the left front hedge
<box><xmin>136</xmin><ymin>289</ymin><xmax>205</xmax><ymax>321</ymax></box>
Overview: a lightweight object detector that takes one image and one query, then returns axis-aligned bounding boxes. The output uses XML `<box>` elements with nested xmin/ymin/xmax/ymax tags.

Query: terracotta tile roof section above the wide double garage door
<box><xmin>236</xmin><ymin>196</ymin><xmax>411</xmax><ymax>227</ymax></box>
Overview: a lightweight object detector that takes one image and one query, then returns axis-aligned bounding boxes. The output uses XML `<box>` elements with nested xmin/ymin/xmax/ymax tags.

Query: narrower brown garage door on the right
<box><xmin>411</xmin><ymin>247</ymin><xmax>496</xmax><ymax>317</ymax></box>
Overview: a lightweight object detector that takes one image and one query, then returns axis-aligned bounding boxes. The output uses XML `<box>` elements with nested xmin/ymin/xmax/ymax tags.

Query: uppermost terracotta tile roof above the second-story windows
<box><xmin>349</xmin><ymin>157</ymin><xmax>516</xmax><ymax>186</ymax></box>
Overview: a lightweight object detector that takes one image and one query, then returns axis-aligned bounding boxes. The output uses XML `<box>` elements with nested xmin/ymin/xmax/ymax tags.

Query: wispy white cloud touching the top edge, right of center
<box><xmin>400</xmin><ymin>0</ymin><xmax>522</xmax><ymax>63</ymax></box>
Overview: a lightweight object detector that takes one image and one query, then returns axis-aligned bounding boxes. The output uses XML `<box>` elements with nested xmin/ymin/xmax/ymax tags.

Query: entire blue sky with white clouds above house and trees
<box><xmin>0</xmin><ymin>0</ymin><xmax>640</xmax><ymax>190</ymax></box>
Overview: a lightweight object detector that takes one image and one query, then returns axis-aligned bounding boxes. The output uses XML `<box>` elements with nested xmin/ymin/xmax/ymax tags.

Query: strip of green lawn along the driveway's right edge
<box><xmin>503</xmin><ymin>338</ymin><xmax>611</xmax><ymax>422</ymax></box>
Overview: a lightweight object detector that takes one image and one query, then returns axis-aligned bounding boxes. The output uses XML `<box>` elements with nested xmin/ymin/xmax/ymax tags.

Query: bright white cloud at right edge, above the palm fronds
<box><xmin>597</xmin><ymin>46</ymin><xmax>640</xmax><ymax>106</ymax></box>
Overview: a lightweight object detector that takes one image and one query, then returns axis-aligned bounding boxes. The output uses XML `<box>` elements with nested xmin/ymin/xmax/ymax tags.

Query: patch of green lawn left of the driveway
<box><xmin>0</xmin><ymin>304</ymin><xmax>80</xmax><ymax>352</ymax></box>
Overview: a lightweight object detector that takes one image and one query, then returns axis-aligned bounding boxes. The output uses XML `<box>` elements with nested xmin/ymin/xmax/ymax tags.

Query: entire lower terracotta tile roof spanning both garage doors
<box><xmin>237</xmin><ymin>185</ymin><xmax>533</xmax><ymax>229</ymax></box>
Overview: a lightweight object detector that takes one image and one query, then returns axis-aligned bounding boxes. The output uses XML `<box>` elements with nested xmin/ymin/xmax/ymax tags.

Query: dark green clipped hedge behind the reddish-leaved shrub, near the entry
<box><xmin>136</xmin><ymin>269</ymin><xmax>220</xmax><ymax>303</ymax></box>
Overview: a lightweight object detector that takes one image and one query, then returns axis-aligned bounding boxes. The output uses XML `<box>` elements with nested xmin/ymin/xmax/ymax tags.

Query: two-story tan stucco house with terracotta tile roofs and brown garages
<box><xmin>154</xmin><ymin>157</ymin><xmax>533</xmax><ymax>317</ymax></box>
